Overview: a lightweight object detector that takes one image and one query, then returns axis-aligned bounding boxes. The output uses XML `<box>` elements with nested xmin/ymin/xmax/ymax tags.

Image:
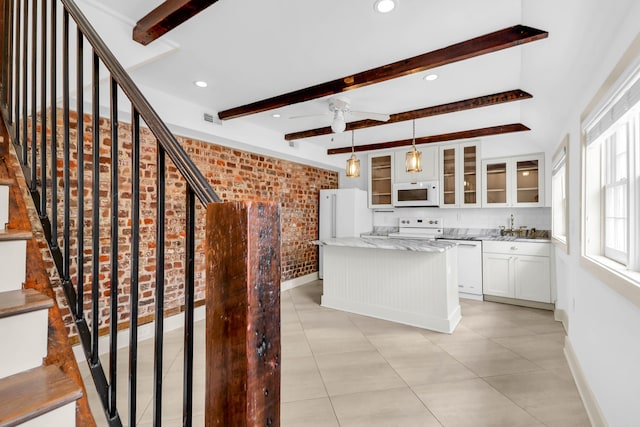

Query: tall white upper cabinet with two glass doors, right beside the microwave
<box><xmin>440</xmin><ymin>142</ymin><xmax>480</xmax><ymax>208</ymax></box>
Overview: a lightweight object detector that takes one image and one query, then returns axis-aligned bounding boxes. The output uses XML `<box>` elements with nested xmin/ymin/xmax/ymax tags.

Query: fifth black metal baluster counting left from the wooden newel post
<box><xmin>90</xmin><ymin>49</ymin><xmax>100</xmax><ymax>365</ymax></box>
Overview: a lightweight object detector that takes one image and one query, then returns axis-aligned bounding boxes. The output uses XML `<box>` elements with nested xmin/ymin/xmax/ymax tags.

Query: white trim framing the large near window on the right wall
<box><xmin>580</xmin><ymin>31</ymin><xmax>640</xmax><ymax>307</ymax></box>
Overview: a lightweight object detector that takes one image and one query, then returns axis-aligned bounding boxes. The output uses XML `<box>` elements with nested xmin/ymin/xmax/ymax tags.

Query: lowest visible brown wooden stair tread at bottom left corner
<box><xmin>0</xmin><ymin>365</ymin><xmax>82</xmax><ymax>427</ymax></box>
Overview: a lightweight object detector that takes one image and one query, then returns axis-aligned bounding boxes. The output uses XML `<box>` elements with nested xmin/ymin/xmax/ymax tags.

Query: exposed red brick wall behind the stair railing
<box><xmin>32</xmin><ymin>112</ymin><xmax>338</xmax><ymax>333</ymax></box>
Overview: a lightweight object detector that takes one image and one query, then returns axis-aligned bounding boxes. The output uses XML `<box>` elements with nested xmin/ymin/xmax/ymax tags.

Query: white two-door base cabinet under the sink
<box><xmin>482</xmin><ymin>241</ymin><xmax>551</xmax><ymax>303</ymax></box>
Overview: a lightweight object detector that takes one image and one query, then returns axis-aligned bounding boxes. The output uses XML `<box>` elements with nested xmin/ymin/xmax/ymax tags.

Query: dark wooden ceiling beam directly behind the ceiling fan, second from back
<box><xmin>284</xmin><ymin>89</ymin><xmax>533</xmax><ymax>141</ymax></box>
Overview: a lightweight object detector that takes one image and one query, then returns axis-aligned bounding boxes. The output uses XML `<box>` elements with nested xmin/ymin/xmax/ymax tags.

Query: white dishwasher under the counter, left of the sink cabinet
<box><xmin>442</xmin><ymin>240</ymin><xmax>482</xmax><ymax>300</ymax></box>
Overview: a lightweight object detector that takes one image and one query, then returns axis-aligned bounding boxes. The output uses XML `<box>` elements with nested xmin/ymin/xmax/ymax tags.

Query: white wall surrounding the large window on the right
<box><xmin>549</xmin><ymin>0</ymin><xmax>640</xmax><ymax>426</ymax></box>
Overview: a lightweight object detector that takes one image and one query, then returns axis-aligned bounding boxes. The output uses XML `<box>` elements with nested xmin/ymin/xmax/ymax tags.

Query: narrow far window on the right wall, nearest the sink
<box><xmin>551</xmin><ymin>135</ymin><xmax>569</xmax><ymax>252</ymax></box>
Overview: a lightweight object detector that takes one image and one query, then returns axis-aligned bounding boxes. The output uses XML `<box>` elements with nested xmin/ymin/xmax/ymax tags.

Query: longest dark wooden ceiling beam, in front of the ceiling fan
<box><xmin>218</xmin><ymin>25</ymin><xmax>549</xmax><ymax>120</ymax></box>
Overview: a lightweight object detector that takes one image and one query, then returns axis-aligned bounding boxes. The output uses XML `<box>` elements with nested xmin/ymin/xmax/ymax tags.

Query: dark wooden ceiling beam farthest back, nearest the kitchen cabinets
<box><xmin>327</xmin><ymin>123</ymin><xmax>531</xmax><ymax>154</ymax></box>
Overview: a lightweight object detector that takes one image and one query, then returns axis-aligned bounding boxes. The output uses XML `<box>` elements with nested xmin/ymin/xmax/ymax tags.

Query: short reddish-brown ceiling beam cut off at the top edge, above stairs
<box><xmin>133</xmin><ymin>0</ymin><xmax>218</xmax><ymax>46</ymax></box>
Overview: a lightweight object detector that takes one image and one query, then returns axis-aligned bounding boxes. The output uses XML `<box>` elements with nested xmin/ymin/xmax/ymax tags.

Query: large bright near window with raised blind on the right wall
<box><xmin>584</xmin><ymin>58</ymin><xmax>640</xmax><ymax>296</ymax></box>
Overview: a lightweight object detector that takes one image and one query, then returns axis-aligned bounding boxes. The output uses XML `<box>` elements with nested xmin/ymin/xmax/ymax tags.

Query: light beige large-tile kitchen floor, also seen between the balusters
<box><xmin>83</xmin><ymin>281</ymin><xmax>590</xmax><ymax>427</ymax></box>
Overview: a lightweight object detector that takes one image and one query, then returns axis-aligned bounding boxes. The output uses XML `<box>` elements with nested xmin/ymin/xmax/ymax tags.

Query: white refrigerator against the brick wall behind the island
<box><xmin>318</xmin><ymin>188</ymin><xmax>373</xmax><ymax>279</ymax></box>
